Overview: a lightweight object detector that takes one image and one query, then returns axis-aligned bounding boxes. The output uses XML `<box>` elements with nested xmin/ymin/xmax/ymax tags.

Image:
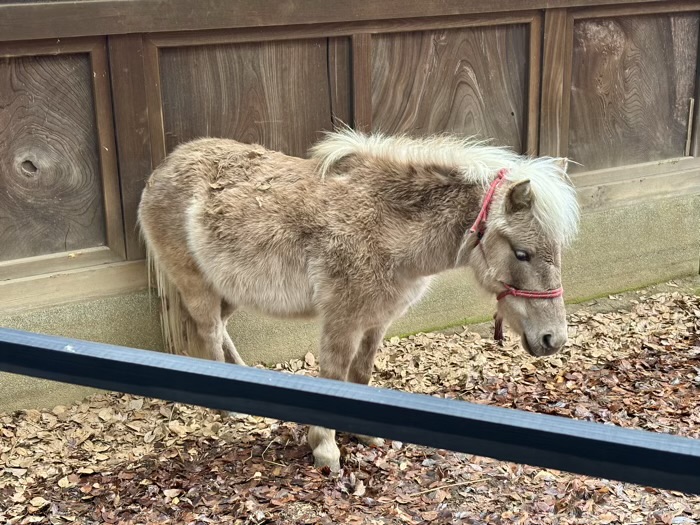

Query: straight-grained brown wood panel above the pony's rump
<box><xmin>160</xmin><ymin>38</ymin><xmax>349</xmax><ymax>156</ymax></box>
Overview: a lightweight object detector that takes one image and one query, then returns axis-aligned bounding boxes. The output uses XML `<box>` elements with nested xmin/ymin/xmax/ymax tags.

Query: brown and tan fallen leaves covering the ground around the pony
<box><xmin>0</xmin><ymin>284</ymin><xmax>700</xmax><ymax>525</ymax></box>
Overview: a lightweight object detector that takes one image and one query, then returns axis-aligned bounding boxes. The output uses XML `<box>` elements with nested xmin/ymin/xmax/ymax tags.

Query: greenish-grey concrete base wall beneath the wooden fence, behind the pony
<box><xmin>0</xmin><ymin>195</ymin><xmax>700</xmax><ymax>412</ymax></box>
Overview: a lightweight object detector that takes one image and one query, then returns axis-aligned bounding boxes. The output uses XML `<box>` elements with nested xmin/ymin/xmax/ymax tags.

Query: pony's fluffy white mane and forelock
<box><xmin>310</xmin><ymin>128</ymin><xmax>579</xmax><ymax>245</ymax></box>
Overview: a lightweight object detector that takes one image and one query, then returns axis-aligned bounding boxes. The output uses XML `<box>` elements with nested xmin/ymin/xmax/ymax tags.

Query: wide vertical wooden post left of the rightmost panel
<box><xmin>539</xmin><ymin>9</ymin><xmax>571</xmax><ymax>157</ymax></box>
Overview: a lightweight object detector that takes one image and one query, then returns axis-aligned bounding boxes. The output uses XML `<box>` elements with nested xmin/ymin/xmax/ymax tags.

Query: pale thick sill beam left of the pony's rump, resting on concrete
<box><xmin>0</xmin><ymin>261</ymin><xmax>148</xmax><ymax>314</ymax></box>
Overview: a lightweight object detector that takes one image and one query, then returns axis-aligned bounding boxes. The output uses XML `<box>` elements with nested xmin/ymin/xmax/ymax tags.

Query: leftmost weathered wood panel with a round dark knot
<box><xmin>0</xmin><ymin>54</ymin><xmax>106</xmax><ymax>261</ymax></box>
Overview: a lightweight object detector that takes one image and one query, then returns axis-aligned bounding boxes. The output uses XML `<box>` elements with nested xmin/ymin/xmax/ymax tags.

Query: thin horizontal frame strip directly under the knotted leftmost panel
<box><xmin>0</xmin><ymin>246</ymin><xmax>121</xmax><ymax>281</ymax></box>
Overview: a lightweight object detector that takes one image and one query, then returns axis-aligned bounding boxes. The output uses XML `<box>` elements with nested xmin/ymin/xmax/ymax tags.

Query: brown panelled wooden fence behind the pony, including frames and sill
<box><xmin>0</xmin><ymin>0</ymin><xmax>700</xmax><ymax>309</ymax></box>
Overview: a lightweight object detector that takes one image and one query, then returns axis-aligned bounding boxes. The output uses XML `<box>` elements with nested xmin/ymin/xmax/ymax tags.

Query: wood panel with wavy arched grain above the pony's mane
<box><xmin>372</xmin><ymin>24</ymin><xmax>529</xmax><ymax>151</ymax></box>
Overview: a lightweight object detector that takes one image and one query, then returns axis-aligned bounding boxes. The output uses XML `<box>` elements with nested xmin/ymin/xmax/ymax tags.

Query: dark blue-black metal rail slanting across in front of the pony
<box><xmin>0</xmin><ymin>328</ymin><xmax>700</xmax><ymax>494</ymax></box>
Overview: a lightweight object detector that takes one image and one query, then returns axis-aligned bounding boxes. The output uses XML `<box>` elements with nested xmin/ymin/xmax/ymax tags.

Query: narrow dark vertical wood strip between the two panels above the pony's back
<box><xmin>328</xmin><ymin>37</ymin><xmax>352</xmax><ymax>126</ymax></box>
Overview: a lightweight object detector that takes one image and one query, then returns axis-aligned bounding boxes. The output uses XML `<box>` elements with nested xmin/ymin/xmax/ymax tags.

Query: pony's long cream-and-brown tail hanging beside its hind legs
<box><xmin>146</xmin><ymin>249</ymin><xmax>205</xmax><ymax>359</ymax></box>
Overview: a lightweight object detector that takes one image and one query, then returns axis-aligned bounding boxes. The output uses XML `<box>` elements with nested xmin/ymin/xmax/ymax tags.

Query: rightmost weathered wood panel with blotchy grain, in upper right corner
<box><xmin>568</xmin><ymin>13</ymin><xmax>698</xmax><ymax>171</ymax></box>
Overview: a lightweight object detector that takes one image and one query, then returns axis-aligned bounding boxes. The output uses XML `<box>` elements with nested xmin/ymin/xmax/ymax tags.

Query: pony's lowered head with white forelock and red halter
<box><xmin>464</xmin><ymin>158</ymin><xmax>579</xmax><ymax>356</ymax></box>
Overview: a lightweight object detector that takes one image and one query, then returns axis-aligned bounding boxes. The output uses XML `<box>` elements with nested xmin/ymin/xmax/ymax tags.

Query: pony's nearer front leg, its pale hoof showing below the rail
<box><xmin>307</xmin><ymin>319</ymin><xmax>362</xmax><ymax>472</ymax></box>
